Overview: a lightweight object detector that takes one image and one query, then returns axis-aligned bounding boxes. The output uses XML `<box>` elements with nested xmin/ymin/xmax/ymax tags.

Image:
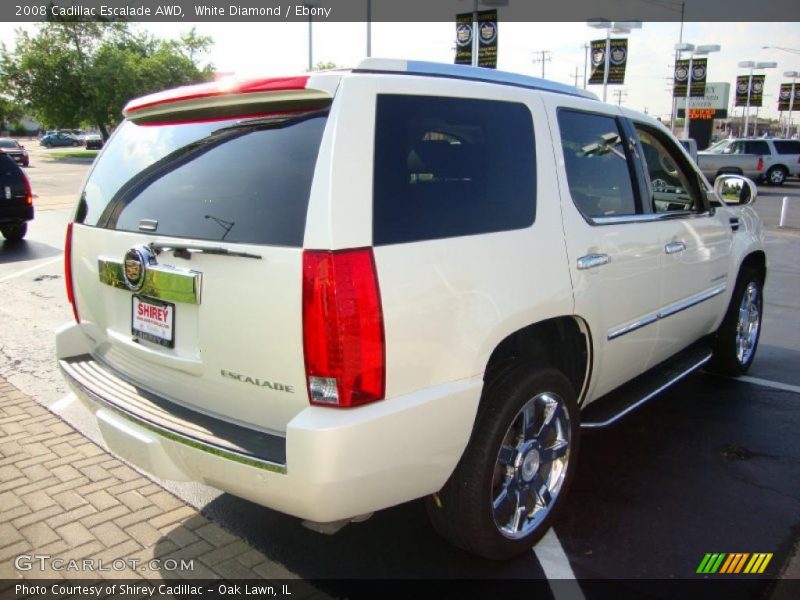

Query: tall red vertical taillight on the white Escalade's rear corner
<box><xmin>303</xmin><ymin>248</ymin><xmax>386</xmax><ymax>407</ymax></box>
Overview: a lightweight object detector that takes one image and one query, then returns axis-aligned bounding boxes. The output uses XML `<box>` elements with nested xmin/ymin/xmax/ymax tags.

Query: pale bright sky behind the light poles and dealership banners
<box><xmin>0</xmin><ymin>20</ymin><xmax>800</xmax><ymax>122</ymax></box>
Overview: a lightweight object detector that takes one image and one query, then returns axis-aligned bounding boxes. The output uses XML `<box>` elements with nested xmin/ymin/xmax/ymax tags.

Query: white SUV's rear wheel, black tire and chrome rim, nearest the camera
<box><xmin>426</xmin><ymin>364</ymin><xmax>579</xmax><ymax>560</ymax></box>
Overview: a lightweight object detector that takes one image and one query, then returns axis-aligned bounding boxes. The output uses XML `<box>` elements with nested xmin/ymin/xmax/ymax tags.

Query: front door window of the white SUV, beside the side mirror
<box><xmin>636</xmin><ymin>124</ymin><xmax>703</xmax><ymax>213</ymax></box>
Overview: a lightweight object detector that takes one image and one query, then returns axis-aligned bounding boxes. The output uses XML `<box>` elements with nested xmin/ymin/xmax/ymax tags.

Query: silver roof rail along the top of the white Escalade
<box><xmin>353</xmin><ymin>58</ymin><xmax>598</xmax><ymax>100</ymax></box>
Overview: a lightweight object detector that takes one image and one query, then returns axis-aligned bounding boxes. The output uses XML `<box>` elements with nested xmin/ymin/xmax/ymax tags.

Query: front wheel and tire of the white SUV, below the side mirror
<box><xmin>709</xmin><ymin>267</ymin><xmax>764</xmax><ymax>377</ymax></box>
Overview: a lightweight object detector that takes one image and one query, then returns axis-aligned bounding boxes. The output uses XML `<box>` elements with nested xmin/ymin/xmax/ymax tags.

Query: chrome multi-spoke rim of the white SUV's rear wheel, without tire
<box><xmin>491</xmin><ymin>392</ymin><xmax>570</xmax><ymax>539</ymax></box>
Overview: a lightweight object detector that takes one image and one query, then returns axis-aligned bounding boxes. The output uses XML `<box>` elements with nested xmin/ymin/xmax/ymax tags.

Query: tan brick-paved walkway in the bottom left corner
<box><xmin>0</xmin><ymin>378</ymin><xmax>295</xmax><ymax>579</ymax></box>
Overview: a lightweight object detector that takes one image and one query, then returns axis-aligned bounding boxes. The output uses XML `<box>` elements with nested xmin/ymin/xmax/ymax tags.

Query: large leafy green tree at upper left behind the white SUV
<box><xmin>0</xmin><ymin>21</ymin><xmax>213</xmax><ymax>138</ymax></box>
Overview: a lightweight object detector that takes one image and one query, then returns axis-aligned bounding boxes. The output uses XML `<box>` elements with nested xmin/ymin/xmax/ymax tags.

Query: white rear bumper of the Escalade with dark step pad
<box><xmin>56</xmin><ymin>324</ymin><xmax>482</xmax><ymax>522</ymax></box>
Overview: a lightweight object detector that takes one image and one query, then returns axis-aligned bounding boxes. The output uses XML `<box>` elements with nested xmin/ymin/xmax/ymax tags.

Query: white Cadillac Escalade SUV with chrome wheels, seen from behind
<box><xmin>57</xmin><ymin>59</ymin><xmax>766</xmax><ymax>559</ymax></box>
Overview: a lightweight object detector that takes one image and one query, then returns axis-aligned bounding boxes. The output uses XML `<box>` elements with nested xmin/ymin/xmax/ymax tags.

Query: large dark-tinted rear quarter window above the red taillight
<box><xmin>373</xmin><ymin>95</ymin><xmax>536</xmax><ymax>245</ymax></box>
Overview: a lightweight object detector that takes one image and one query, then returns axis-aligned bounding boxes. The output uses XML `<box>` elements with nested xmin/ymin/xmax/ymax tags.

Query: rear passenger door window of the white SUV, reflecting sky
<box><xmin>558</xmin><ymin>109</ymin><xmax>637</xmax><ymax>219</ymax></box>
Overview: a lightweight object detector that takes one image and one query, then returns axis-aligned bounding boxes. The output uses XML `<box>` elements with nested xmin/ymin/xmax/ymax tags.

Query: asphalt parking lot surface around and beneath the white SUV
<box><xmin>0</xmin><ymin>143</ymin><xmax>800</xmax><ymax>598</ymax></box>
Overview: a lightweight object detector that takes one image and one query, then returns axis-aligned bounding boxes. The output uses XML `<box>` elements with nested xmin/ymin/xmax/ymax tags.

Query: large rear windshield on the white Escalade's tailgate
<box><xmin>76</xmin><ymin>112</ymin><xmax>327</xmax><ymax>246</ymax></box>
